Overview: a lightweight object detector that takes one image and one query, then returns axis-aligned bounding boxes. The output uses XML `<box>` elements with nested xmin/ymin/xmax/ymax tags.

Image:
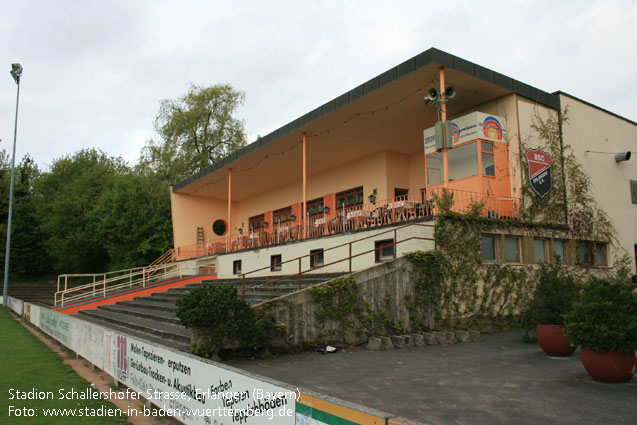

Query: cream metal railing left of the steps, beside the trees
<box><xmin>54</xmin><ymin>263</ymin><xmax>183</xmax><ymax>307</ymax></box>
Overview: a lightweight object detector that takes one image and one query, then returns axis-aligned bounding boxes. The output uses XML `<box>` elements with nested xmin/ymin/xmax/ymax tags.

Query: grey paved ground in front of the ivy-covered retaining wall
<box><xmin>226</xmin><ymin>332</ymin><xmax>637</xmax><ymax>425</ymax></box>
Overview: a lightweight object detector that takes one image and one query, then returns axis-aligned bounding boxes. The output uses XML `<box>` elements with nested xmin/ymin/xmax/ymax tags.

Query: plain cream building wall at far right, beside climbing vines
<box><xmin>560</xmin><ymin>95</ymin><xmax>637</xmax><ymax>273</ymax></box>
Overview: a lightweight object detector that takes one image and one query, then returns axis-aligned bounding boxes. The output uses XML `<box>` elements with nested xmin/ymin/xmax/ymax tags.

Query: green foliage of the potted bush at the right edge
<box><xmin>565</xmin><ymin>278</ymin><xmax>637</xmax><ymax>354</ymax></box>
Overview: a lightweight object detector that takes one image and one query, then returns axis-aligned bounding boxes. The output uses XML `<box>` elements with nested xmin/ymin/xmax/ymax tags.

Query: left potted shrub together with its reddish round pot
<box><xmin>521</xmin><ymin>264</ymin><xmax>580</xmax><ymax>356</ymax></box>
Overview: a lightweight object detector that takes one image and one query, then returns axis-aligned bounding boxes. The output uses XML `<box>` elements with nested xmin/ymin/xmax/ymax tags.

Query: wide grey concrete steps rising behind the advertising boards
<box><xmin>78</xmin><ymin>273</ymin><xmax>343</xmax><ymax>351</ymax></box>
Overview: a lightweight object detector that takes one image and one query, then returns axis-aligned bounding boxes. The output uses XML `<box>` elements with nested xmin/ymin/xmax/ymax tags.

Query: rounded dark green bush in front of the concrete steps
<box><xmin>177</xmin><ymin>283</ymin><xmax>276</xmax><ymax>356</ymax></box>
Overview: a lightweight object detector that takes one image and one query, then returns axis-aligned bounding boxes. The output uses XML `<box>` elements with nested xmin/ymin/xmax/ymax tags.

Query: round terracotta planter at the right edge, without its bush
<box><xmin>580</xmin><ymin>347</ymin><xmax>637</xmax><ymax>382</ymax></box>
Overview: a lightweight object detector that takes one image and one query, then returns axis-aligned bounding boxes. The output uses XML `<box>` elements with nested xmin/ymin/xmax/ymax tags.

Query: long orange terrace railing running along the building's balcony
<box><xmin>174</xmin><ymin>188</ymin><xmax>520</xmax><ymax>260</ymax></box>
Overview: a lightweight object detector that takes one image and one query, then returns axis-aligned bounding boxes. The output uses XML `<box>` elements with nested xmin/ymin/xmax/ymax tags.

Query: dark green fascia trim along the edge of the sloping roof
<box><xmin>173</xmin><ymin>47</ymin><xmax>560</xmax><ymax>192</ymax></box>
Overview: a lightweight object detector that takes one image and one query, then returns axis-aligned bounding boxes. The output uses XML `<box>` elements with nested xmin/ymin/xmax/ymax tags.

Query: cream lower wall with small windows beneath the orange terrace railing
<box><xmin>217</xmin><ymin>222</ymin><xmax>434</xmax><ymax>279</ymax></box>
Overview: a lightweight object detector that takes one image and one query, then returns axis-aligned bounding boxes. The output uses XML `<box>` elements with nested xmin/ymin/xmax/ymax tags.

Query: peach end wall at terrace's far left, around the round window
<box><xmin>170</xmin><ymin>192</ymin><xmax>230</xmax><ymax>247</ymax></box>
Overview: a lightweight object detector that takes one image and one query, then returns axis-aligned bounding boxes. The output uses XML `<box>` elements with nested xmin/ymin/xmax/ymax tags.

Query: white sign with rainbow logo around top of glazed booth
<box><xmin>423</xmin><ymin>111</ymin><xmax>507</xmax><ymax>155</ymax></box>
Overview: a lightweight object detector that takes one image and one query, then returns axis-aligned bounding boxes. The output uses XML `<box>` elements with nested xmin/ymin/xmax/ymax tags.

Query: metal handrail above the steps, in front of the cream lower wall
<box><xmin>241</xmin><ymin>223</ymin><xmax>436</xmax><ymax>297</ymax></box>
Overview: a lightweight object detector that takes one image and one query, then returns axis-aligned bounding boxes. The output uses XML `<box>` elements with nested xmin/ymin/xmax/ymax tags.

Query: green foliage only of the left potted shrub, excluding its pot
<box><xmin>520</xmin><ymin>264</ymin><xmax>581</xmax><ymax>330</ymax></box>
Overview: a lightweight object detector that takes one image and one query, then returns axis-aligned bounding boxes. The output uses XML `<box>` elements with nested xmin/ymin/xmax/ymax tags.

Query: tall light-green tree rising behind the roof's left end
<box><xmin>140</xmin><ymin>84</ymin><xmax>246</xmax><ymax>183</ymax></box>
